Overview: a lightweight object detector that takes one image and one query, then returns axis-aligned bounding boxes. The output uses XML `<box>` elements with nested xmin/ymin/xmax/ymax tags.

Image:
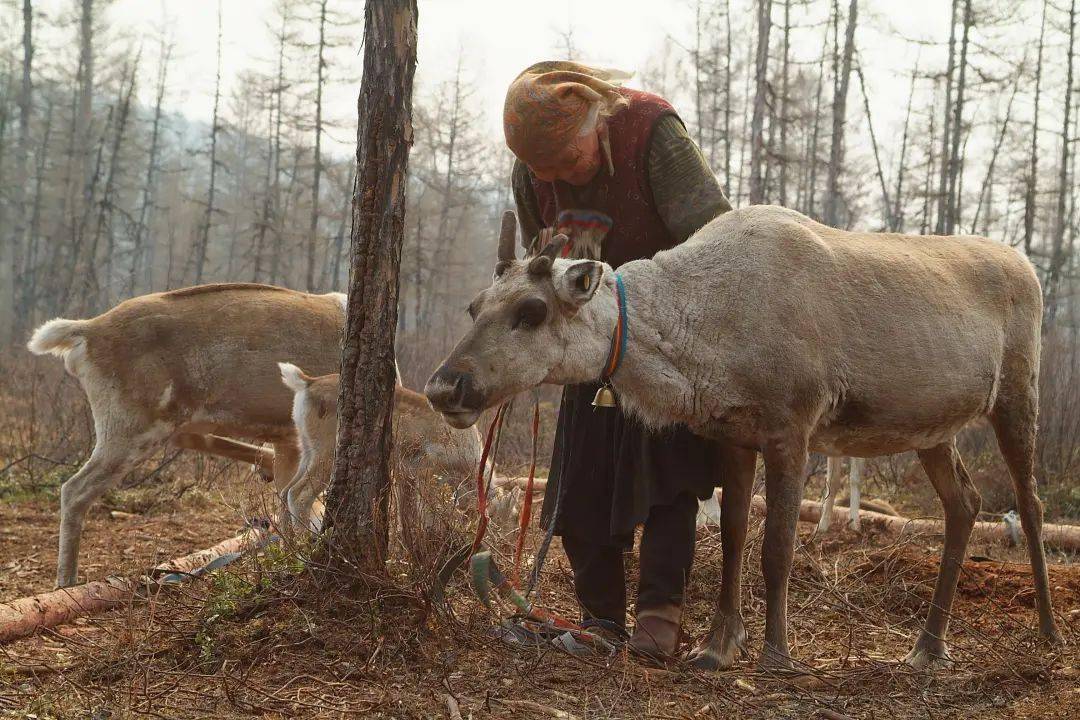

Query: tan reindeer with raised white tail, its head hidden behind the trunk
<box><xmin>27</xmin><ymin>284</ymin><xmax>346</xmax><ymax>587</ymax></box>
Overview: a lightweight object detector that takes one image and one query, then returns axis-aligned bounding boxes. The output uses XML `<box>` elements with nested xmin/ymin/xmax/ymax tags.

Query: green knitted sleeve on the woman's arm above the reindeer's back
<box><xmin>649</xmin><ymin>116</ymin><xmax>731</xmax><ymax>243</ymax></box>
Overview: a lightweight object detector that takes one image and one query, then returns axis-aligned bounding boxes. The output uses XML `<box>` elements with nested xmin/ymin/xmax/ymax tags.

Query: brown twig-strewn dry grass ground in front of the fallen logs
<box><xmin>0</xmin><ymin>500</ymin><xmax>1080</xmax><ymax>718</ymax></box>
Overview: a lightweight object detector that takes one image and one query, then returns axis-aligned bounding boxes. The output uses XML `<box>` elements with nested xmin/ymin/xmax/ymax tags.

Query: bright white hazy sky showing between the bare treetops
<box><xmin>37</xmin><ymin>0</ymin><xmax>980</xmax><ymax>157</ymax></box>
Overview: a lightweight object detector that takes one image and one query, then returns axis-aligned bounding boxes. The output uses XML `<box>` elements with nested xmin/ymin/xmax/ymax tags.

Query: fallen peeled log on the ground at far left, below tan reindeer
<box><xmin>0</xmin><ymin>529</ymin><xmax>267</xmax><ymax>643</ymax></box>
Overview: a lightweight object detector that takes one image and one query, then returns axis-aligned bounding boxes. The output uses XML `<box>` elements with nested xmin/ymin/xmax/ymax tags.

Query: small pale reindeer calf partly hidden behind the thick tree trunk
<box><xmin>279</xmin><ymin>363</ymin><xmax>517</xmax><ymax>532</ymax></box>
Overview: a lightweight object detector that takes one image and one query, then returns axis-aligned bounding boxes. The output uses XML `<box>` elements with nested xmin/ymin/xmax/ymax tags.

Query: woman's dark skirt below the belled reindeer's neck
<box><xmin>540</xmin><ymin>384</ymin><xmax>720</xmax><ymax>546</ymax></box>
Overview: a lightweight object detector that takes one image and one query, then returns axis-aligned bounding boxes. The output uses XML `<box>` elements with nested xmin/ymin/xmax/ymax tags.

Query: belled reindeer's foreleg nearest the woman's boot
<box><xmin>687</xmin><ymin>447</ymin><xmax>757</xmax><ymax>670</ymax></box>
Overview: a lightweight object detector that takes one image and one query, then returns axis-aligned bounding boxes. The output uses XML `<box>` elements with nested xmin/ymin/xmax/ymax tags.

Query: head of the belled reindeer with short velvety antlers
<box><xmin>424</xmin><ymin>210</ymin><xmax>618</xmax><ymax>427</ymax></box>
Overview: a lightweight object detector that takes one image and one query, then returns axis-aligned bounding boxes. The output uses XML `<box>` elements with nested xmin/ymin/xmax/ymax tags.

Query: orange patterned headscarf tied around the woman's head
<box><xmin>502</xmin><ymin>60</ymin><xmax>631</xmax><ymax>163</ymax></box>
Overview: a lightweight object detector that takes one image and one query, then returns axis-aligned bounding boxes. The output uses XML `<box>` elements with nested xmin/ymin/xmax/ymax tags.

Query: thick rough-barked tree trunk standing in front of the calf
<box><xmin>325</xmin><ymin>0</ymin><xmax>417</xmax><ymax>578</ymax></box>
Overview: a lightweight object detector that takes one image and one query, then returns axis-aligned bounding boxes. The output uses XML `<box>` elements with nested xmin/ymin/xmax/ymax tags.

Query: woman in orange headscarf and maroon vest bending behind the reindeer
<box><xmin>503</xmin><ymin>62</ymin><xmax>731</xmax><ymax>656</ymax></box>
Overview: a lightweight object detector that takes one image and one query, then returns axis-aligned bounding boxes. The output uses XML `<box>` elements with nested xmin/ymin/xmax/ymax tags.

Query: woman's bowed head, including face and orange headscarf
<box><xmin>503</xmin><ymin>62</ymin><xmax>629</xmax><ymax>185</ymax></box>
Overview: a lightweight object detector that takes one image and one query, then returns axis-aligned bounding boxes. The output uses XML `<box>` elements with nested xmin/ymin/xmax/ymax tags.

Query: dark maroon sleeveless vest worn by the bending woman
<box><xmin>532</xmin><ymin>87</ymin><xmax>676</xmax><ymax>268</ymax></box>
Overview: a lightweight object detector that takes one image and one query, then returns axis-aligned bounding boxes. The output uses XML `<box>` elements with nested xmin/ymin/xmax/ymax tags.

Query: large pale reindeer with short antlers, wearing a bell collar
<box><xmin>426</xmin><ymin>205</ymin><xmax>1061</xmax><ymax>668</ymax></box>
